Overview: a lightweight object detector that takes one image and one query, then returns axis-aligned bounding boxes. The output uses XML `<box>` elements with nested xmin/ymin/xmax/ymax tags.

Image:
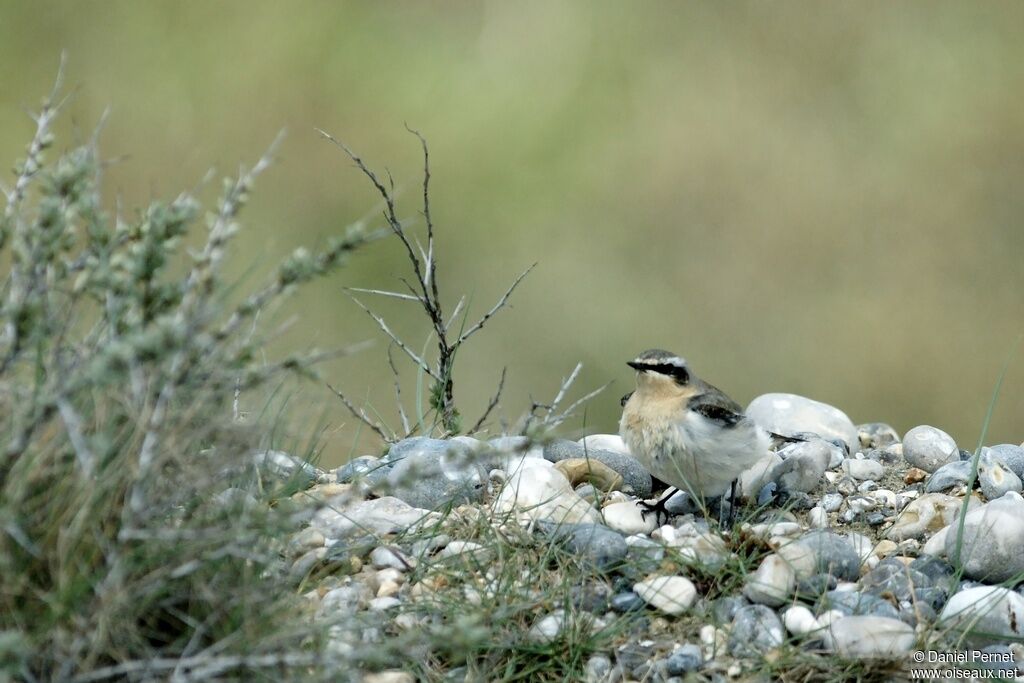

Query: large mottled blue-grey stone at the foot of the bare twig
<box><xmin>387</xmin><ymin>438</ymin><xmax>487</xmax><ymax>510</ymax></box>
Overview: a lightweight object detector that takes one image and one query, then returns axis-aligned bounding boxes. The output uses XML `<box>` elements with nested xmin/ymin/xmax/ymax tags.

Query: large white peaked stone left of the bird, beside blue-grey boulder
<box><xmin>494</xmin><ymin>459</ymin><xmax>600</xmax><ymax>524</ymax></box>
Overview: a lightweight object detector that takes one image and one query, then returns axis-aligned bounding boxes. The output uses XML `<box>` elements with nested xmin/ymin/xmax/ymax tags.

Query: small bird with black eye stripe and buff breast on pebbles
<box><xmin>618</xmin><ymin>349</ymin><xmax>771</xmax><ymax>522</ymax></box>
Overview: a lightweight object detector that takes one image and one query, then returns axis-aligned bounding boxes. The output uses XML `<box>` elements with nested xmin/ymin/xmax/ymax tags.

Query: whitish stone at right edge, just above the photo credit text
<box><xmin>939</xmin><ymin>586</ymin><xmax>1024</xmax><ymax>645</ymax></box>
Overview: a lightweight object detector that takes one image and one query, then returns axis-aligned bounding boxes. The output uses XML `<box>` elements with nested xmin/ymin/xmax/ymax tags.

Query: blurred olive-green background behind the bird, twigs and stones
<box><xmin>0</xmin><ymin>1</ymin><xmax>1024</xmax><ymax>463</ymax></box>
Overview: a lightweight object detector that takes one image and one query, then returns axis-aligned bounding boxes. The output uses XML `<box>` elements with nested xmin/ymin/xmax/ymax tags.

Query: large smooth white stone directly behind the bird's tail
<box><xmin>746</xmin><ymin>393</ymin><xmax>860</xmax><ymax>452</ymax></box>
